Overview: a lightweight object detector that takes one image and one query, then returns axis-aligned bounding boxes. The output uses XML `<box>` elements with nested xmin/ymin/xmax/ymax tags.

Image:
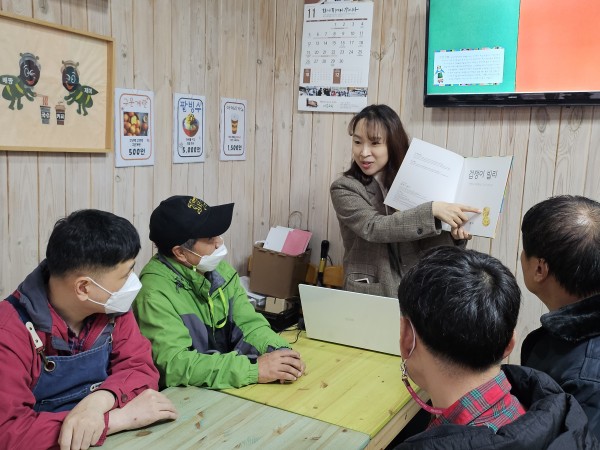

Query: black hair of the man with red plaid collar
<box><xmin>398</xmin><ymin>246</ymin><xmax>521</xmax><ymax>372</ymax></box>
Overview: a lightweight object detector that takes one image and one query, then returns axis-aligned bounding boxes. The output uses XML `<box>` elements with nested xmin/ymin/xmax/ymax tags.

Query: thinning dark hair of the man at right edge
<box><xmin>521</xmin><ymin>195</ymin><xmax>600</xmax><ymax>298</ymax></box>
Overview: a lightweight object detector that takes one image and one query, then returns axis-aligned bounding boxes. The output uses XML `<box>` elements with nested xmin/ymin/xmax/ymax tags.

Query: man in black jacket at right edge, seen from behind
<box><xmin>521</xmin><ymin>195</ymin><xmax>600</xmax><ymax>438</ymax></box>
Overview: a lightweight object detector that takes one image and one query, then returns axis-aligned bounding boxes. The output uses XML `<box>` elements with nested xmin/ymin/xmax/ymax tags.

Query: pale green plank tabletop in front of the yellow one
<box><xmin>102</xmin><ymin>386</ymin><xmax>369</xmax><ymax>450</ymax></box>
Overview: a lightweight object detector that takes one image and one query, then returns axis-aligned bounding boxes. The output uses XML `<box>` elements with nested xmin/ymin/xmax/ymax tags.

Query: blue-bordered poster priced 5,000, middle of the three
<box><xmin>173</xmin><ymin>94</ymin><xmax>206</xmax><ymax>164</ymax></box>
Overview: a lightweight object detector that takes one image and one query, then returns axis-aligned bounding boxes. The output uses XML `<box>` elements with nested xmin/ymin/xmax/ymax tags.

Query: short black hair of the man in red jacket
<box><xmin>46</xmin><ymin>209</ymin><xmax>141</xmax><ymax>276</ymax></box>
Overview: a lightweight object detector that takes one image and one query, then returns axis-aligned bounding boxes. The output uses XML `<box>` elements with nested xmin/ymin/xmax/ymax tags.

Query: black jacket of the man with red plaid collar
<box><xmin>396</xmin><ymin>365</ymin><xmax>600</xmax><ymax>450</ymax></box>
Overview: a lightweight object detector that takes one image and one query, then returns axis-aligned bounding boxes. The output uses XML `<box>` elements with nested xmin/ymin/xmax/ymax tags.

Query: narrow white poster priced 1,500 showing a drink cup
<box><xmin>220</xmin><ymin>98</ymin><xmax>247</xmax><ymax>161</ymax></box>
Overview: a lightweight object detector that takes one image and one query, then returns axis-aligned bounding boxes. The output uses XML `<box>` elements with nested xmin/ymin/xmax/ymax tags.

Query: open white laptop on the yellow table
<box><xmin>299</xmin><ymin>284</ymin><xmax>400</xmax><ymax>355</ymax></box>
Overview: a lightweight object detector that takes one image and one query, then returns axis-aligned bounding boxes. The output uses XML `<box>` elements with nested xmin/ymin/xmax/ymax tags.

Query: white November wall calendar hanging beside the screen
<box><xmin>298</xmin><ymin>0</ymin><xmax>373</xmax><ymax>112</ymax></box>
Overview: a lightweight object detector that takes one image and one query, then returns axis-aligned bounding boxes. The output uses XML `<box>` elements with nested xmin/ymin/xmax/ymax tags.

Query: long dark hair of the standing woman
<box><xmin>344</xmin><ymin>105</ymin><xmax>409</xmax><ymax>189</ymax></box>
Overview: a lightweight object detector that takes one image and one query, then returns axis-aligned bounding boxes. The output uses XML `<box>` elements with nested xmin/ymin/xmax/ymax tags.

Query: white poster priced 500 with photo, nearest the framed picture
<box><xmin>115</xmin><ymin>88</ymin><xmax>154</xmax><ymax>167</ymax></box>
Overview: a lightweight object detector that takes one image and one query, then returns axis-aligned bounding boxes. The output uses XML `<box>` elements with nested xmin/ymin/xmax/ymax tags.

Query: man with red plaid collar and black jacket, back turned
<box><xmin>397</xmin><ymin>247</ymin><xmax>600</xmax><ymax>450</ymax></box>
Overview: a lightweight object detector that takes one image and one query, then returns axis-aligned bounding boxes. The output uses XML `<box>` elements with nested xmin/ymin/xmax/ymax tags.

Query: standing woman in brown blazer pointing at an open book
<box><xmin>330</xmin><ymin>105</ymin><xmax>480</xmax><ymax>297</ymax></box>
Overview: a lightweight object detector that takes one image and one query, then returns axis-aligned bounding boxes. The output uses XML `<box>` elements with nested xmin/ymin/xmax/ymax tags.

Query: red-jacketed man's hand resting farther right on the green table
<box><xmin>107</xmin><ymin>389</ymin><xmax>177</xmax><ymax>434</ymax></box>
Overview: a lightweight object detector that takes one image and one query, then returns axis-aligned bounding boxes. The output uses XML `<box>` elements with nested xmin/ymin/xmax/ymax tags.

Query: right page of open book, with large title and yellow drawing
<box><xmin>456</xmin><ymin>156</ymin><xmax>513</xmax><ymax>238</ymax></box>
